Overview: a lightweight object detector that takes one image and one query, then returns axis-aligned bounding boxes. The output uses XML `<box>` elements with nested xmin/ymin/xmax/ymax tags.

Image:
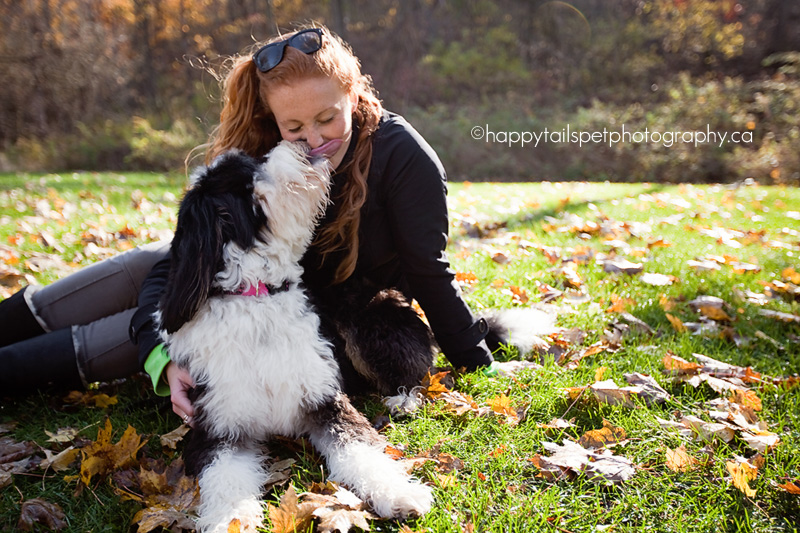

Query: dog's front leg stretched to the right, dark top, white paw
<box><xmin>308</xmin><ymin>393</ymin><xmax>433</xmax><ymax>518</ymax></box>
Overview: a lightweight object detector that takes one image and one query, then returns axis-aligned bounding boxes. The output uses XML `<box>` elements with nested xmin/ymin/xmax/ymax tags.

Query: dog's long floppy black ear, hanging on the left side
<box><xmin>160</xmin><ymin>185</ymin><xmax>224</xmax><ymax>333</ymax></box>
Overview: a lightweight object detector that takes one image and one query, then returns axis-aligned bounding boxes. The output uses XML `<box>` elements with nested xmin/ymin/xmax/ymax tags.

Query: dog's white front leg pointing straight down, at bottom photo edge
<box><xmin>197</xmin><ymin>442</ymin><xmax>267</xmax><ymax>533</ymax></box>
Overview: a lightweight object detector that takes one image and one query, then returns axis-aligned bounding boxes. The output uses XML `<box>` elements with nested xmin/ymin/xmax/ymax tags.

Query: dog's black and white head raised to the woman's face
<box><xmin>159</xmin><ymin>142</ymin><xmax>328</xmax><ymax>333</ymax></box>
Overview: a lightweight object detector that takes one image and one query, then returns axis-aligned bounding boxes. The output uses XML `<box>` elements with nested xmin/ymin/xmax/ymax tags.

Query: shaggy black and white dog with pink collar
<box><xmin>156</xmin><ymin>142</ymin><xmax>434</xmax><ymax>532</ymax></box>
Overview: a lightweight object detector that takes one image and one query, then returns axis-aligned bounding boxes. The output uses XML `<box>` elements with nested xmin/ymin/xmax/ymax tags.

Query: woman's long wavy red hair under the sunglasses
<box><xmin>206</xmin><ymin>28</ymin><xmax>383</xmax><ymax>283</ymax></box>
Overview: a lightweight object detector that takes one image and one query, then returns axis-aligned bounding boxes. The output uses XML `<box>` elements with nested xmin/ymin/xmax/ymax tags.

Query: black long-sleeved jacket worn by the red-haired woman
<box><xmin>131</xmin><ymin>112</ymin><xmax>492</xmax><ymax>370</ymax></box>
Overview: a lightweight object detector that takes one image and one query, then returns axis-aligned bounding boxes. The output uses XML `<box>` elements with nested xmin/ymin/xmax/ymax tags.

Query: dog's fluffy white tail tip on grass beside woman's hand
<box><xmin>480</xmin><ymin>307</ymin><xmax>558</xmax><ymax>355</ymax></box>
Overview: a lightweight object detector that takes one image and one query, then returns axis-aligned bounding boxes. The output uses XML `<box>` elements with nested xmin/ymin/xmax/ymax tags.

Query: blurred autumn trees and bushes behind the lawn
<box><xmin>0</xmin><ymin>0</ymin><xmax>800</xmax><ymax>180</ymax></box>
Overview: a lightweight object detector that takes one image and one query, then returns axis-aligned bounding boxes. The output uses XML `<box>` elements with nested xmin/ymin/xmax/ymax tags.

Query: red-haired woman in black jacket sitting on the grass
<box><xmin>0</xmin><ymin>23</ymin><xmax>493</xmax><ymax>420</ymax></box>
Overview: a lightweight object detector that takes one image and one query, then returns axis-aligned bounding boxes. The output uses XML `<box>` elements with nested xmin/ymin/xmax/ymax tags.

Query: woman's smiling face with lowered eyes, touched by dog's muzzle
<box><xmin>267</xmin><ymin>77</ymin><xmax>358</xmax><ymax>168</ymax></box>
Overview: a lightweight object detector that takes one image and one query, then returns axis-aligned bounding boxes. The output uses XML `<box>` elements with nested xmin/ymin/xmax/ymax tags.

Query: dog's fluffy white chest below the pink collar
<box><xmin>169</xmin><ymin>290</ymin><xmax>339</xmax><ymax>438</ymax></box>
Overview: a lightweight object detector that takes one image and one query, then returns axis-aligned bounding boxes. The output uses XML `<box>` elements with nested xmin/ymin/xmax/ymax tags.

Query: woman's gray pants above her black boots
<box><xmin>25</xmin><ymin>241</ymin><xmax>170</xmax><ymax>384</ymax></box>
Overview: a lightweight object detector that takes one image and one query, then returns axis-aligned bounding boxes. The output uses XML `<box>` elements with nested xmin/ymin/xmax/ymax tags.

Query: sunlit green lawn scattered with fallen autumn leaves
<box><xmin>0</xmin><ymin>174</ymin><xmax>800</xmax><ymax>533</ymax></box>
